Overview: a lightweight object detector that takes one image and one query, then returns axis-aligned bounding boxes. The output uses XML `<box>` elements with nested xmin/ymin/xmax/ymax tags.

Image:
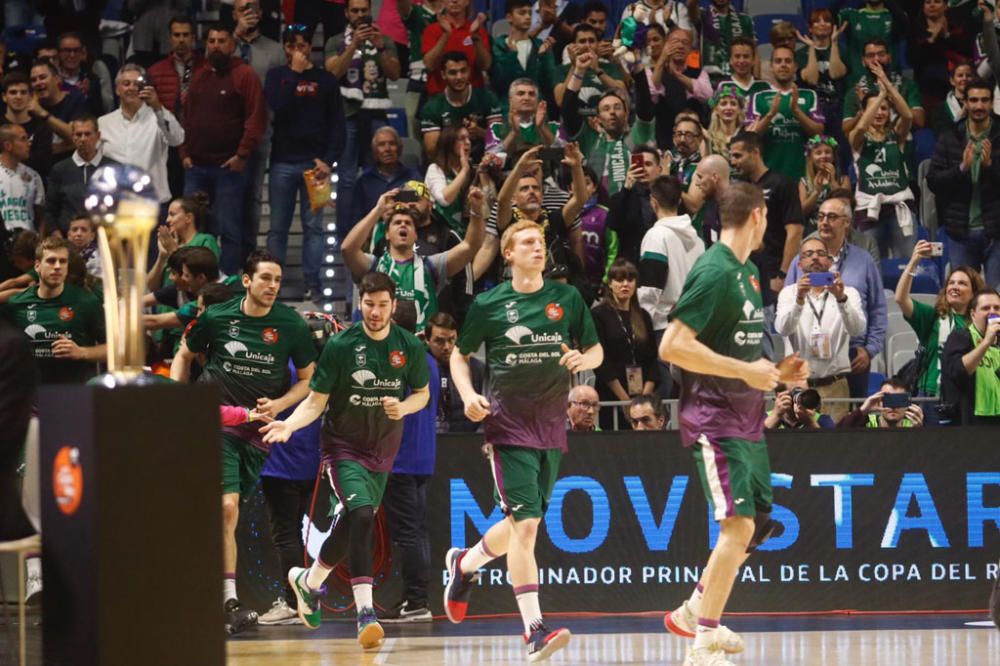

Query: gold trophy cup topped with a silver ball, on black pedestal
<box><xmin>84</xmin><ymin>165</ymin><xmax>160</xmax><ymax>387</ymax></box>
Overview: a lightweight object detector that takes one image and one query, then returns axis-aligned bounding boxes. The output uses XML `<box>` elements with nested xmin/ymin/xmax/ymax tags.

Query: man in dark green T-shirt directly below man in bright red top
<box><xmin>420</xmin><ymin>51</ymin><xmax>503</xmax><ymax>159</ymax></box>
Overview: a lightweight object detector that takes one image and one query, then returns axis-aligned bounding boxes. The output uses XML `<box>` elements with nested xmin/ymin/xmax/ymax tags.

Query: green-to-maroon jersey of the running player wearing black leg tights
<box><xmin>310</xmin><ymin>322</ymin><xmax>430</xmax><ymax>472</ymax></box>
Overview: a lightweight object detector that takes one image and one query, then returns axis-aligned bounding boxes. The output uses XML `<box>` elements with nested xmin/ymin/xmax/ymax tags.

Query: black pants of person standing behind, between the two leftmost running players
<box><xmin>260</xmin><ymin>476</ymin><xmax>315</xmax><ymax>608</ymax></box>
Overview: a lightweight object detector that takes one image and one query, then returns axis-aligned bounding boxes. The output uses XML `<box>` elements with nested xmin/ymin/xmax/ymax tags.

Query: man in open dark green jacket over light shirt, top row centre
<box><xmin>494</xmin><ymin>0</ymin><xmax>559</xmax><ymax>104</ymax></box>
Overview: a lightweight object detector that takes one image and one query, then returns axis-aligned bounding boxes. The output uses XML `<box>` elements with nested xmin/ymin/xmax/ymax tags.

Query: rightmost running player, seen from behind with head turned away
<box><xmin>660</xmin><ymin>183</ymin><xmax>809</xmax><ymax>666</ymax></box>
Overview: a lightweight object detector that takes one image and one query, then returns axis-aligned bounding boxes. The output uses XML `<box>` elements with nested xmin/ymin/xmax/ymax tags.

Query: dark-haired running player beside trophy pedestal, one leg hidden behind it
<box><xmin>170</xmin><ymin>250</ymin><xmax>316</xmax><ymax>633</ymax></box>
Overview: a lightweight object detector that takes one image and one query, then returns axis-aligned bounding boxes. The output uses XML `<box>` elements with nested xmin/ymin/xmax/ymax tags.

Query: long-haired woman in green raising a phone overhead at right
<box><xmin>896</xmin><ymin>241</ymin><xmax>985</xmax><ymax>420</ymax></box>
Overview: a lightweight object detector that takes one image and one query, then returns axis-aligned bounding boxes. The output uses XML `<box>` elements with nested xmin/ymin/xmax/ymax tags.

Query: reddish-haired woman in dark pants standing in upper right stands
<box><xmin>795</xmin><ymin>7</ymin><xmax>847</xmax><ymax>143</ymax></box>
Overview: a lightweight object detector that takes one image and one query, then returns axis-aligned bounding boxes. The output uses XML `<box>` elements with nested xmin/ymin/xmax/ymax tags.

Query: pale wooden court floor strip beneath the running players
<box><xmin>227</xmin><ymin>614</ymin><xmax>1000</xmax><ymax>666</ymax></box>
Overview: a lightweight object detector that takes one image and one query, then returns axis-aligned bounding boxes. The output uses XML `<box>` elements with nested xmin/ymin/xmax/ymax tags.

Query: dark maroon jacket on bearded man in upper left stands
<box><xmin>180</xmin><ymin>58</ymin><xmax>267</xmax><ymax>166</ymax></box>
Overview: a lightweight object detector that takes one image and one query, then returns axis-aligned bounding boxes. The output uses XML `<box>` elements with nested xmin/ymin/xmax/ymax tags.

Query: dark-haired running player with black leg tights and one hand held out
<box><xmin>261</xmin><ymin>273</ymin><xmax>430</xmax><ymax>649</ymax></box>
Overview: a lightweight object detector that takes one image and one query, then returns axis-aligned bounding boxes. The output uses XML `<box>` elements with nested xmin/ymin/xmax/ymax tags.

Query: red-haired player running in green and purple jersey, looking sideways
<box><xmin>444</xmin><ymin>220</ymin><xmax>604</xmax><ymax>661</ymax></box>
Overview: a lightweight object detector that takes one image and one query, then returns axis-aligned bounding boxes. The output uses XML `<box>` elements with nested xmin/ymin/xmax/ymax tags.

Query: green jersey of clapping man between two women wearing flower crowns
<box><xmin>747</xmin><ymin>88</ymin><xmax>823</xmax><ymax>181</ymax></box>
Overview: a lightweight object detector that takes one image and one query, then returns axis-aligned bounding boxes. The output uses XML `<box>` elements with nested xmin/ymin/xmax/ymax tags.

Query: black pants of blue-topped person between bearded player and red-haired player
<box><xmin>382</xmin><ymin>474</ymin><xmax>431</xmax><ymax>609</ymax></box>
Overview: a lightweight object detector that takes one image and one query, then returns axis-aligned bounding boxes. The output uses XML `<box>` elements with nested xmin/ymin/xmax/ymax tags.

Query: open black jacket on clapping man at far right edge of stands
<box><xmin>927</xmin><ymin>115</ymin><xmax>1000</xmax><ymax>239</ymax></box>
